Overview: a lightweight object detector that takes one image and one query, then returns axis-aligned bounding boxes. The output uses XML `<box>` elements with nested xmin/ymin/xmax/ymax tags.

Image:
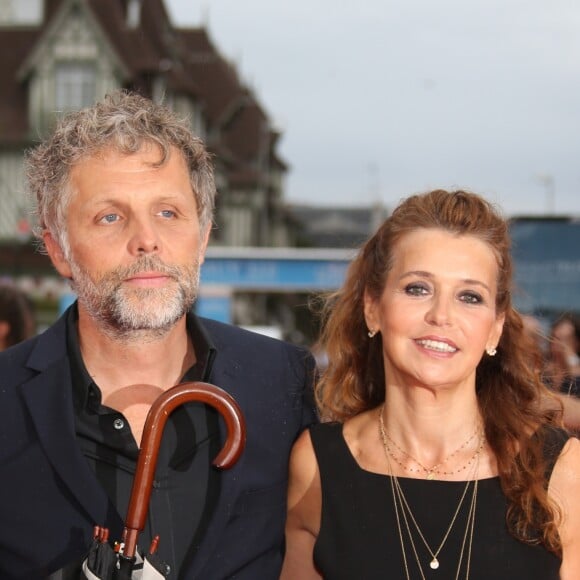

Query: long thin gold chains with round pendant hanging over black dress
<box><xmin>379</xmin><ymin>405</ymin><xmax>483</xmax><ymax>580</ymax></box>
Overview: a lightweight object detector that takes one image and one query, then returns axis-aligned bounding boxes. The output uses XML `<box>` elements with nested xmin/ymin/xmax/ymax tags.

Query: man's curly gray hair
<box><xmin>26</xmin><ymin>91</ymin><xmax>216</xmax><ymax>255</ymax></box>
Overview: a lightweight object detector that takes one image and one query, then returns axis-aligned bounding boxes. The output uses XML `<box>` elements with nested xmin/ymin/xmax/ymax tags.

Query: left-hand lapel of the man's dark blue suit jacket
<box><xmin>22</xmin><ymin>321</ymin><xmax>110</xmax><ymax>525</ymax></box>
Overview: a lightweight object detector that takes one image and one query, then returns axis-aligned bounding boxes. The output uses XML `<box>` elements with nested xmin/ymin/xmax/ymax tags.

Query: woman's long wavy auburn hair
<box><xmin>316</xmin><ymin>190</ymin><xmax>561</xmax><ymax>554</ymax></box>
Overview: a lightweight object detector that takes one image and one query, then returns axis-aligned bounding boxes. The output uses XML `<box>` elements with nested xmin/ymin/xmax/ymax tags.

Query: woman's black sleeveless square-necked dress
<box><xmin>310</xmin><ymin>423</ymin><xmax>567</xmax><ymax>580</ymax></box>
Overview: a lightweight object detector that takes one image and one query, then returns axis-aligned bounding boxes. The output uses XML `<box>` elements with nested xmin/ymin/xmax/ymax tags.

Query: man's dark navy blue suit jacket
<box><xmin>0</xmin><ymin>310</ymin><xmax>316</xmax><ymax>580</ymax></box>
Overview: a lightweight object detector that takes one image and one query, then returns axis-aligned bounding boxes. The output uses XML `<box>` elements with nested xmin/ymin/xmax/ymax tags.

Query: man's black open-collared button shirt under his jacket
<box><xmin>67</xmin><ymin>308</ymin><xmax>220</xmax><ymax>578</ymax></box>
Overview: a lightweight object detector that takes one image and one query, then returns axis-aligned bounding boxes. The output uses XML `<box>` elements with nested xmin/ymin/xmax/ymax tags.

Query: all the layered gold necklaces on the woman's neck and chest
<box><xmin>379</xmin><ymin>405</ymin><xmax>485</xmax><ymax>580</ymax></box>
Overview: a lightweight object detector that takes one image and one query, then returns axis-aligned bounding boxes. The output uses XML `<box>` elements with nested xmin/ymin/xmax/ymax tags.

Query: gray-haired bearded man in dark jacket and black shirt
<box><xmin>0</xmin><ymin>92</ymin><xmax>315</xmax><ymax>580</ymax></box>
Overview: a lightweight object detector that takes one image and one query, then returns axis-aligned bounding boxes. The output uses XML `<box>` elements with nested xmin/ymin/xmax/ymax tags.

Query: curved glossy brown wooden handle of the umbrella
<box><xmin>123</xmin><ymin>382</ymin><xmax>246</xmax><ymax>558</ymax></box>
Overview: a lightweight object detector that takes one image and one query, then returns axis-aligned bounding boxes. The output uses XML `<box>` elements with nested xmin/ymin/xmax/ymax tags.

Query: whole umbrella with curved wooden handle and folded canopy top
<box><xmin>81</xmin><ymin>382</ymin><xmax>246</xmax><ymax>580</ymax></box>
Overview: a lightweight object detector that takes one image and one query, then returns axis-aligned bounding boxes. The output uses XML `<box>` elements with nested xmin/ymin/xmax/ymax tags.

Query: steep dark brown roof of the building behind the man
<box><xmin>0</xmin><ymin>0</ymin><xmax>286</xmax><ymax>188</ymax></box>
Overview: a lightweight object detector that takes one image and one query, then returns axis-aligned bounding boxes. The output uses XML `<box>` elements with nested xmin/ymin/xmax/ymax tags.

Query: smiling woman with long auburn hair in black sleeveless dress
<box><xmin>282</xmin><ymin>190</ymin><xmax>580</xmax><ymax>580</ymax></box>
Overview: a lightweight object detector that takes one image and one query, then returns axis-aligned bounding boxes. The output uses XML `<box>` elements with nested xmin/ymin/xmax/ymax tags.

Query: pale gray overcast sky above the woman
<box><xmin>166</xmin><ymin>0</ymin><xmax>580</xmax><ymax>215</ymax></box>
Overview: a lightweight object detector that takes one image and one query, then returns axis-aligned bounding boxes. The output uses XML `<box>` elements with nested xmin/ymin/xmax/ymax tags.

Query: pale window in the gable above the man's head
<box><xmin>55</xmin><ymin>62</ymin><xmax>97</xmax><ymax>111</ymax></box>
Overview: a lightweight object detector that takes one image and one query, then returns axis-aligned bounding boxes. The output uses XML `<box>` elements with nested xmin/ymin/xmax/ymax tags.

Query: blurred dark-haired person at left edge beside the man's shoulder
<box><xmin>0</xmin><ymin>284</ymin><xmax>36</xmax><ymax>351</ymax></box>
